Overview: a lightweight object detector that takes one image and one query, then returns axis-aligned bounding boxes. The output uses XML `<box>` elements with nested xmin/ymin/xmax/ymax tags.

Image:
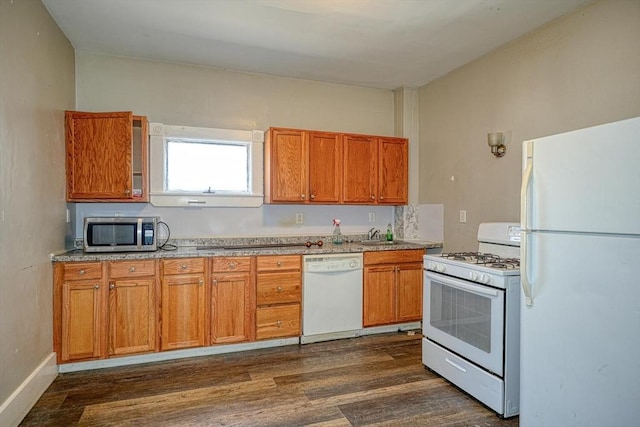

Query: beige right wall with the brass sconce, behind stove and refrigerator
<box><xmin>419</xmin><ymin>0</ymin><xmax>640</xmax><ymax>250</ymax></box>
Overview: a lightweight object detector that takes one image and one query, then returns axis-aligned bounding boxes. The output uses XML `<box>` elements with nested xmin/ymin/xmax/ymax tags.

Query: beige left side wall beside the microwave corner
<box><xmin>0</xmin><ymin>0</ymin><xmax>74</xmax><ymax>418</ymax></box>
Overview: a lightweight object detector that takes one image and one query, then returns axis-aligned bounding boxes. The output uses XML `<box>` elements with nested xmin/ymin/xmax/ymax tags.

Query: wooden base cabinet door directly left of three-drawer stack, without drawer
<box><xmin>210</xmin><ymin>272</ymin><xmax>253</xmax><ymax>343</ymax></box>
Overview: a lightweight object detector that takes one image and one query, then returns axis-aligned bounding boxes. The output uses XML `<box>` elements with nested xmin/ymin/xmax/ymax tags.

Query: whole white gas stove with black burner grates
<box><xmin>422</xmin><ymin>223</ymin><xmax>520</xmax><ymax>417</ymax></box>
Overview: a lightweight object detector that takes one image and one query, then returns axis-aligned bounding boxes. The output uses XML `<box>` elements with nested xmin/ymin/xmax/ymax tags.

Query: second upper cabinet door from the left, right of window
<box><xmin>308</xmin><ymin>132</ymin><xmax>342</xmax><ymax>203</ymax></box>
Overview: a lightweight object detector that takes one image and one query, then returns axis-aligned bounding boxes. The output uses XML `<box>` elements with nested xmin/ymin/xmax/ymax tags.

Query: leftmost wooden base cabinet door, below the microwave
<box><xmin>60</xmin><ymin>280</ymin><xmax>106</xmax><ymax>362</ymax></box>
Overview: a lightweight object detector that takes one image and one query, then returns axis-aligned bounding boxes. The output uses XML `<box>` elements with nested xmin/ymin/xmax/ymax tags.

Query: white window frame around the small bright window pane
<box><xmin>149</xmin><ymin>123</ymin><xmax>264</xmax><ymax>208</ymax></box>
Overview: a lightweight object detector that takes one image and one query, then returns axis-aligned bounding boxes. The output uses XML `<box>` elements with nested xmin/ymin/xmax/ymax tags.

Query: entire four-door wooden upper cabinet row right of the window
<box><xmin>265</xmin><ymin>128</ymin><xmax>409</xmax><ymax>205</ymax></box>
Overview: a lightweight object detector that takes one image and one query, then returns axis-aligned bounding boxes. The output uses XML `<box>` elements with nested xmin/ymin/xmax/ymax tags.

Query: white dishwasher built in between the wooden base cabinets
<box><xmin>300</xmin><ymin>253</ymin><xmax>363</xmax><ymax>344</ymax></box>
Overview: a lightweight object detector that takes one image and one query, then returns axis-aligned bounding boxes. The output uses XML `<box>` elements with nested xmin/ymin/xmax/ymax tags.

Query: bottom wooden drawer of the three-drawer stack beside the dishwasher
<box><xmin>256</xmin><ymin>304</ymin><xmax>300</xmax><ymax>340</ymax></box>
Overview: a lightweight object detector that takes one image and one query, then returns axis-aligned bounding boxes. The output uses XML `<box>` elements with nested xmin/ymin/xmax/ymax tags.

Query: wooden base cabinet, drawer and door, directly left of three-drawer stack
<box><xmin>209</xmin><ymin>257</ymin><xmax>255</xmax><ymax>344</ymax></box>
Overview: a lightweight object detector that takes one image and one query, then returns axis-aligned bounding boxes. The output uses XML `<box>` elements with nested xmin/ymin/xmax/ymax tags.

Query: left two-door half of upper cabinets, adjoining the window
<box><xmin>264</xmin><ymin>128</ymin><xmax>342</xmax><ymax>203</ymax></box>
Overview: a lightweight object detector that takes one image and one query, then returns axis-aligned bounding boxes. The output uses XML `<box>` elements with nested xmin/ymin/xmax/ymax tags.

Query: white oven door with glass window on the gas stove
<box><xmin>422</xmin><ymin>270</ymin><xmax>504</xmax><ymax>377</ymax></box>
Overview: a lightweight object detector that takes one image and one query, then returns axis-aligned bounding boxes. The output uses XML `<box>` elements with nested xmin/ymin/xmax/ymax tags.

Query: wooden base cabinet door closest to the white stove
<box><xmin>397</xmin><ymin>263</ymin><xmax>423</xmax><ymax>322</ymax></box>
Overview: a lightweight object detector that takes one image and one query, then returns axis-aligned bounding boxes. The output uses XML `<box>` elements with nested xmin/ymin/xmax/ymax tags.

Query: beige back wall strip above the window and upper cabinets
<box><xmin>77</xmin><ymin>52</ymin><xmax>394</xmax><ymax>136</ymax></box>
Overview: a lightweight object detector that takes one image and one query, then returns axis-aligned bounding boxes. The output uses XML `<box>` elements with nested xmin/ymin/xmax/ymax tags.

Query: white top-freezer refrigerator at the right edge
<box><xmin>520</xmin><ymin>117</ymin><xmax>640</xmax><ymax>427</ymax></box>
